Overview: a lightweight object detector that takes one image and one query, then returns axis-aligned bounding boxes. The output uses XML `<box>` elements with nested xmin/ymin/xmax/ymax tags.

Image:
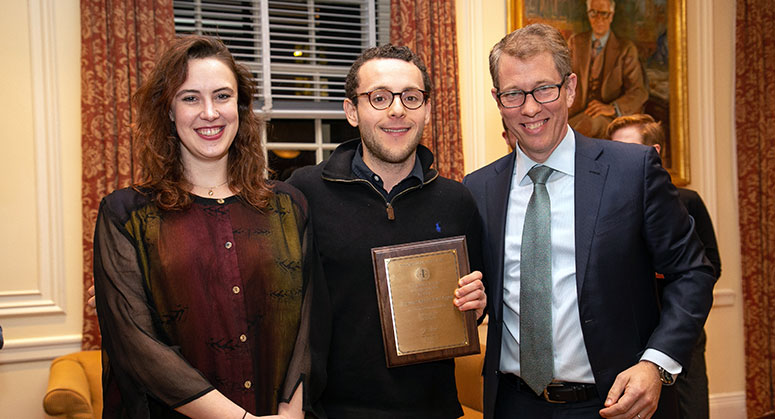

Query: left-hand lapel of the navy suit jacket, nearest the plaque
<box><xmin>486</xmin><ymin>152</ymin><xmax>517</xmax><ymax>321</ymax></box>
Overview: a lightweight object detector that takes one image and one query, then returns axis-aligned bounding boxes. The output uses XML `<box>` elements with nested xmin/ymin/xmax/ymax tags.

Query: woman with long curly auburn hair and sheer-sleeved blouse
<box><xmin>94</xmin><ymin>36</ymin><xmax>320</xmax><ymax>419</ymax></box>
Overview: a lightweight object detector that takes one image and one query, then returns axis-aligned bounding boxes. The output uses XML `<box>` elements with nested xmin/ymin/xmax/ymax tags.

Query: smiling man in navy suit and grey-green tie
<box><xmin>464</xmin><ymin>24</ymin><xmax>714</xmax><ymax>419</ymax></box>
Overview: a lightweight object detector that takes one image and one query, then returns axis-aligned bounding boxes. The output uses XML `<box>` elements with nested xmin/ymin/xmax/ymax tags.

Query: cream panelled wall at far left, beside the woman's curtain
<box><xmin>0</xmin><ymin>0</ymin><xmax>82</xmax><ymax>418</ymax></box>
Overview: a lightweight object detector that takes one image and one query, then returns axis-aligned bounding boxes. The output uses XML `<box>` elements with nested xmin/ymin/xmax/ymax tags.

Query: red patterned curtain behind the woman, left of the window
<box><xmin>81</xmin><ymin>0</ymin><xmax>175</xmax><ymax>349</ymax></box>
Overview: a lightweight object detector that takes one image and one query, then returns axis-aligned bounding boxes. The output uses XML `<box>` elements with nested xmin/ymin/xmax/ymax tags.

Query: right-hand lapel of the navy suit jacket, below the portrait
<box><xmin>574</xmin><ymin>133</ymin><xmax>608</xmax><ymax>295</ymax></box>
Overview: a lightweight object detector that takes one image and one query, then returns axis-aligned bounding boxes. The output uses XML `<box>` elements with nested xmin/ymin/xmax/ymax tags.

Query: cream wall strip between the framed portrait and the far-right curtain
<box><xmin>687</xmin><ymin>0</ymin><xmax>745</xmax><ymax>419</ymax></box>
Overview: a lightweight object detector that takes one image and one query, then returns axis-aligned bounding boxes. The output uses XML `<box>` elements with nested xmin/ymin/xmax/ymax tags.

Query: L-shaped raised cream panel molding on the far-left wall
<box><xmin>0</xmin><ymin>0</ymin><xmax>65</xmax><ymax>317</ymax></box>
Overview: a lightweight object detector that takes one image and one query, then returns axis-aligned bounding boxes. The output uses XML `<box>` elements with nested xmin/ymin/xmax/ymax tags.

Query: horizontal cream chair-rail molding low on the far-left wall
<box><xmin>0</xmin><ymin>334</ymin><xmax>81</xmax><ymax>365</ymax></box>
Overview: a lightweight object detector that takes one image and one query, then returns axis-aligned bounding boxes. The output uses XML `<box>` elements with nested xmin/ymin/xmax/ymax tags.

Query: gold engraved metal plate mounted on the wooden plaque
<box><xmin>385</xmin><ymin>249</ymin><xmax>468</xmax><ymax>356</ymax></box>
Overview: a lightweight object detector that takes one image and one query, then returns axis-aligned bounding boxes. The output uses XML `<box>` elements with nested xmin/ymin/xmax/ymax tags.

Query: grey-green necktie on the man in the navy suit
<box><xmin>519</xmin><ymin>166</ymin><xmax>554</xmax><ymax>394</ymax></box>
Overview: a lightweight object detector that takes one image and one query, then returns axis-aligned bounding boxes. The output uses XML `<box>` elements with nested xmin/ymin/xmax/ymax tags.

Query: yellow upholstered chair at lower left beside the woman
<box><xmin>43</xmin><ymin>351</ymin><xmax>102</xmax><ymax>419</ymax></box>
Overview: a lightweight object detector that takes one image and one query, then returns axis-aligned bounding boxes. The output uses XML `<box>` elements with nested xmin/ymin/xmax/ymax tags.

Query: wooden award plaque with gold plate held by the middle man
<box><xmin>371</xmin><ymin>236</ymin><xmax>480</xmax><ymax>368</ymax></box>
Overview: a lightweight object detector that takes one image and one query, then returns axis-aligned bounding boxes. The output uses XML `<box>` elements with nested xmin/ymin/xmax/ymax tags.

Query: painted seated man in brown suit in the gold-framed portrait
<box><xmin>568</xmin><ymin>0</ymin><xmax>649</xmax><ymax>138</ymax></box>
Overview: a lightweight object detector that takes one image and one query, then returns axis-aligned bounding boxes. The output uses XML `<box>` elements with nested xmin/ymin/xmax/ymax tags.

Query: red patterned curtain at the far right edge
<box><xmin>735</xmin><ymin>0</ymin><xmax>775</xmax><ymax>417</ymax></box>
